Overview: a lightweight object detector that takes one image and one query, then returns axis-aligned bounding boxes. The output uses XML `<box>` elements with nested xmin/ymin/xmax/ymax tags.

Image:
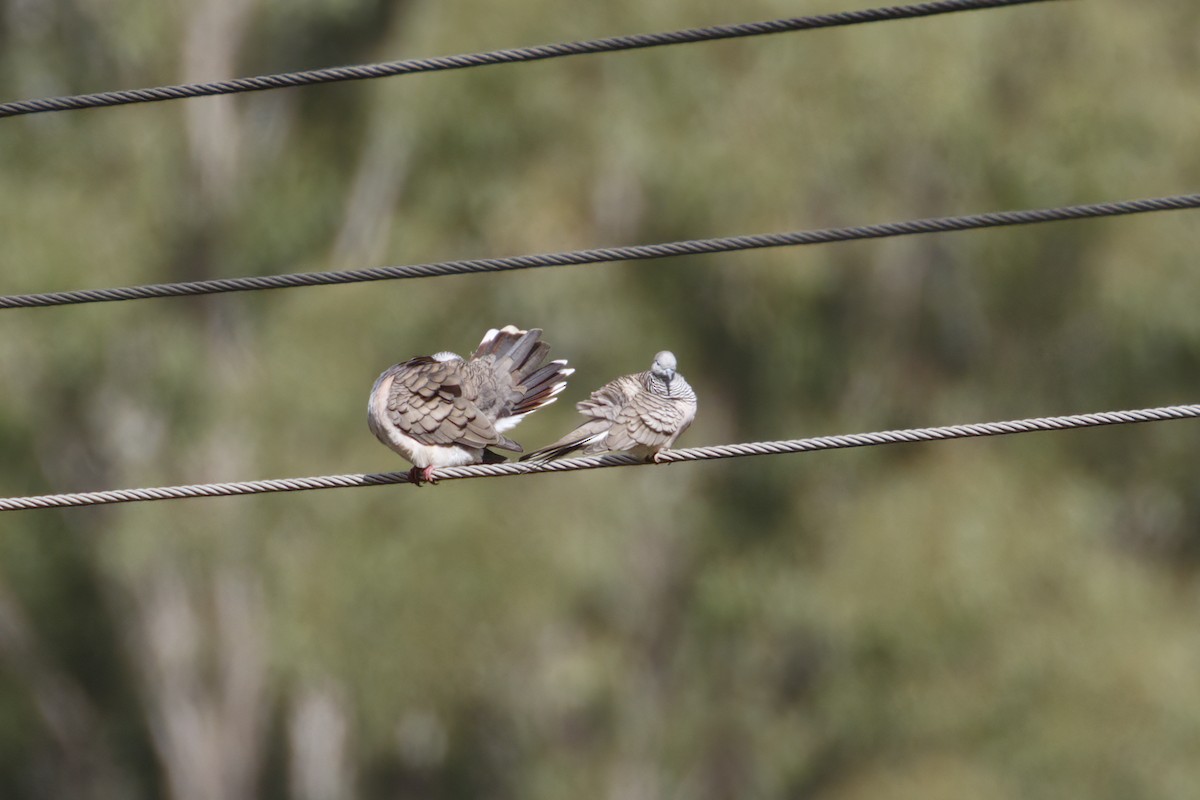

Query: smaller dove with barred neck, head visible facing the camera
<box><xmin>521</xmin><ymin>350</ymin><xmax>696</xmax><ymax>462</ymax></box>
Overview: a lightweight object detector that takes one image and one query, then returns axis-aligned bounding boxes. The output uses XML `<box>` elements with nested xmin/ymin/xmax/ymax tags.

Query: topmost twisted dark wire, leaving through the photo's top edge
<box><xmin>0</xmin><ymin>0</ymin><xmax>1065</xmax><ymax>116</ymax></box>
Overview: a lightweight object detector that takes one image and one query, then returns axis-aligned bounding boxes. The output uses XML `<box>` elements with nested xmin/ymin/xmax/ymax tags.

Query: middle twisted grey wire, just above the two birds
<box><xmin>0</xmin><ymin>194</ymin><xmax>1200</xmax><ymax>309</ymax></box>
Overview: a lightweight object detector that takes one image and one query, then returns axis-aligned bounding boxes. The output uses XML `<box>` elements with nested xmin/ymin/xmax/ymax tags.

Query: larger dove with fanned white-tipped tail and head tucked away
<box><xmin>367</xmin><ymin>325</ymin><xmax>575</xmax><ymax>486</ymax></box>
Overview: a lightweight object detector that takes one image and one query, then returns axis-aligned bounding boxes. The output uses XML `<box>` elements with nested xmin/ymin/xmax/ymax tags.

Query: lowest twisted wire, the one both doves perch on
<box><xmin>0</xmin><ymin>404</ymin><xmax>1200</xmax><ymax>511</ymax></box>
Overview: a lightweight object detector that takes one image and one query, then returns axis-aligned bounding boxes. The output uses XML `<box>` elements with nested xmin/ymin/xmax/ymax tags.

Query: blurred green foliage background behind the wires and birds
<box><xmin>0</xmin><ymin>0</ymin><xmax>1200</xmax><ymax>800</ymax></box>
